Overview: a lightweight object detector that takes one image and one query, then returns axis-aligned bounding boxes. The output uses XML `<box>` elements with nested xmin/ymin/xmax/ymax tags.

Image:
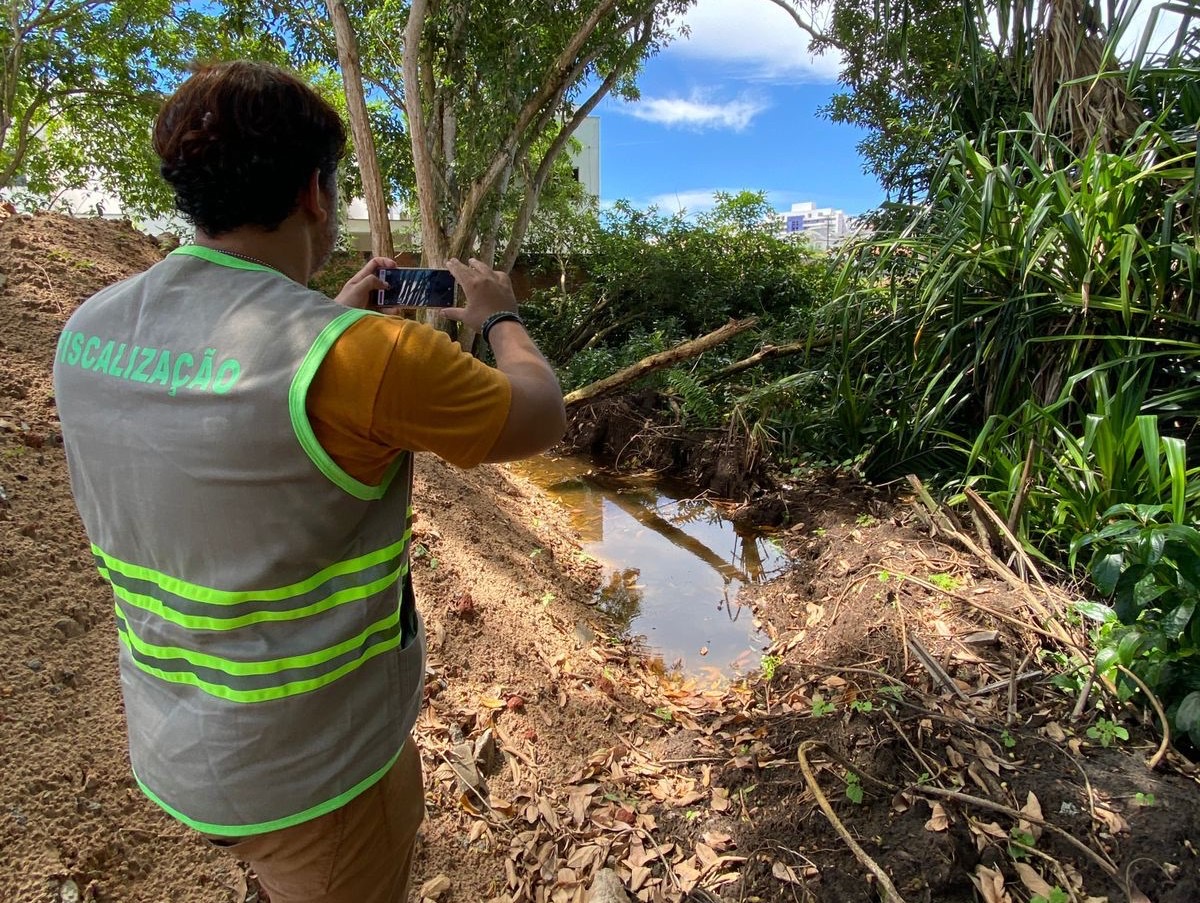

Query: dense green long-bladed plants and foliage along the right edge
<box><xmin>788</xmin><ymin>0</ymin><xmax>1200</xmax><ymax>742</ymax></box>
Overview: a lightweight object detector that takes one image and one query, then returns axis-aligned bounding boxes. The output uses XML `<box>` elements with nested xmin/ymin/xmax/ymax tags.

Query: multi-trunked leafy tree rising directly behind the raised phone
<box><xmin>403</xmin><ymin>0</ymin><xmax>691</xmax><ymax>269</ymax></box>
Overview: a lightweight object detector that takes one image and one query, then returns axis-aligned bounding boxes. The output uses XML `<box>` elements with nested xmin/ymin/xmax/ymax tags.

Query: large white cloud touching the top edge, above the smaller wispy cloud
<box><xmin>667</xmin><ymin>0</ymin><xmax>838</xmax><ymax>82</ymax></box>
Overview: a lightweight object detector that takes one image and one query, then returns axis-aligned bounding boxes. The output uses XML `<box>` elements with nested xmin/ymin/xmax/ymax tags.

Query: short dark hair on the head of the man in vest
<box><xmin>154</xmin><ymin>60</ymin><xmax>346</xmax><ymax>235</ymax></box>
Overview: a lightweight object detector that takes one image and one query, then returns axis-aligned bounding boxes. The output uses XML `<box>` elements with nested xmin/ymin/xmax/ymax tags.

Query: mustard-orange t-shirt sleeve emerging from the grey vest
<box><xmin>307</xmin><ymin>316</ymin><xmax>512</xmax><ymax>485</ymax></box>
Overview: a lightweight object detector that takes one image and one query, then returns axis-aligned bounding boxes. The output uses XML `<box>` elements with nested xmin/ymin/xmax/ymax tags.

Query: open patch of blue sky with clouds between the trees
<box><xmin>595</xmin><ymin>0</ymin><xmax>883</xmax><ymax>214</ymax></box>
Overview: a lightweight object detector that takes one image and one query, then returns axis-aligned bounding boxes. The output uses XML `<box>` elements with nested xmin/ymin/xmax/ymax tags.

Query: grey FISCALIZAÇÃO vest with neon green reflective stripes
<box><xmin>54</xmin><ymin>246</ymin><xmax>425</xmax><ymax>837</ymax></box>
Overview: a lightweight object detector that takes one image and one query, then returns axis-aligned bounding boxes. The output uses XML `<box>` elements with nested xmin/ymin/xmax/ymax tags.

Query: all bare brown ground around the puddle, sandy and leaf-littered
<box><xmin>0</xmin><ymin>216</ymin><xmax>1200</xmax><ymax>903</ymax></box>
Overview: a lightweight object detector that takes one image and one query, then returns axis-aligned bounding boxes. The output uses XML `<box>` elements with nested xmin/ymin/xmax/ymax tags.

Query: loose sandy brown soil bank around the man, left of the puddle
<box><xmin>0</xmin><ymin>216</ymin><xmax>633</xmax><ymax>902</ymax></box>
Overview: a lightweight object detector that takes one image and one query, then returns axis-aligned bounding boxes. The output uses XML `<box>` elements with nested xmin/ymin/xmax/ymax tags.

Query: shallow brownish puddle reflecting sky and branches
<box><xmin>511</xmin><ymin>458</ymin><xmax>787</xmax><ymax>681</ymax></box>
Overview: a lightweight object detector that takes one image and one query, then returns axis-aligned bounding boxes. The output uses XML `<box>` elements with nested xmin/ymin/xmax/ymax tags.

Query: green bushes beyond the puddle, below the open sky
<box><xmin>522</xmin><ymin>192</ymin><xmax>827</xmax><ymax>372</ymax></box>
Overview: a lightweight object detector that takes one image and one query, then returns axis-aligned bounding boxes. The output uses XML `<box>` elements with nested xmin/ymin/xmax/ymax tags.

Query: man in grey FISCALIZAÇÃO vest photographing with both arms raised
<box><xmin>54</xmin><ymin>61</ymin><xmax>565</xmax><ymax>903</ymax></box>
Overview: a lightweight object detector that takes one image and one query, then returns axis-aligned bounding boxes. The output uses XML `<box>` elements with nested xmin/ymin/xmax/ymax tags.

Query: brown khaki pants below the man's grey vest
<box><xmin>212</xmin><ymin>740</ymin><xmax>425</xmax><ymax>903</ymax></box>
